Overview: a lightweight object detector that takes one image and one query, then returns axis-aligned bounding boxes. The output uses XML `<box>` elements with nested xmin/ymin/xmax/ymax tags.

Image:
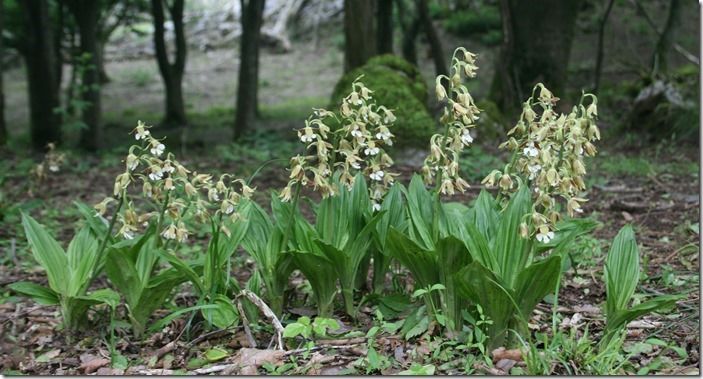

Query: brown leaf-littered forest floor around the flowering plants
<box><xmin>0</xmin><ymin>132</ymin><xmax>700</xmax><ymax>375</ymax></box>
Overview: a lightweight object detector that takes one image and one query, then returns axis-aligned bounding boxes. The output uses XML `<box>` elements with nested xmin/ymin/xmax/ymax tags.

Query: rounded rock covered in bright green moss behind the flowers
<box><xmin>330</xmin><ymin>55</ymin><xmax>437</xmax><ymax>147</ymax></box>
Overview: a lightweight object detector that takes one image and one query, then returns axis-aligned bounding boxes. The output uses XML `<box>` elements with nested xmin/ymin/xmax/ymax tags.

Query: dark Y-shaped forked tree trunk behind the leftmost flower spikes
<box><xmin>151</xmin><ymin>0</ymin><xmax>188</xmax><ymax>127</ymax></box>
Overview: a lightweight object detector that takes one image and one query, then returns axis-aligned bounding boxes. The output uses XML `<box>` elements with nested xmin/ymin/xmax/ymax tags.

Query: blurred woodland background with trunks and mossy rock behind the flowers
<box><xmin>0</xmin><ymin>0</ymin><xmax>700</xmax><ymax>158</ymax></box>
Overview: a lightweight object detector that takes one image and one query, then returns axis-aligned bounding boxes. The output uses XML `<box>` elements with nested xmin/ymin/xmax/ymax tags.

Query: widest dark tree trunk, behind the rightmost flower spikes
<box><xmin>490</xmin><ymin>0</ymin><xmax>581</xmax><ymax>112</ymax></box>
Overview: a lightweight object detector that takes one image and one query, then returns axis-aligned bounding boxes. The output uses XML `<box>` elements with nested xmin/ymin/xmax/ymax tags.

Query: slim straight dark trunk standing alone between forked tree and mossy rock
<box><xmin>234</xmin><ymin>0</ymin><xmax>264</xmax><ymax>140</ymax></box>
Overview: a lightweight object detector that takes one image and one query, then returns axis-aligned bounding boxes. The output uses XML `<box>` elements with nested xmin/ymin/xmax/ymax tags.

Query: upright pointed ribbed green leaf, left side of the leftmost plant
<box><xmin>22</xmin><ymin>213</ymin><xmax>71</xmax><ymax>295</ymax></box>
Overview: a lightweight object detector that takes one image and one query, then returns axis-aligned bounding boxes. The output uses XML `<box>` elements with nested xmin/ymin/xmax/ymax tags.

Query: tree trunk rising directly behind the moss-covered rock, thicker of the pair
<box><xmin>344</xmin><ymin>0</ymin><xmax>376</xmax><ymax>72</ymax></box>
